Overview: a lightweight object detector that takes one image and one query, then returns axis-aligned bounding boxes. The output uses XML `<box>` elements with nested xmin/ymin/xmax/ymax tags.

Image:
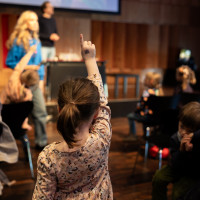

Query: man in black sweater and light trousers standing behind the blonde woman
<box><xmin>39</xmin><ymin>1</ymin><xmax>60</xmax><ymax>61</ymax></box>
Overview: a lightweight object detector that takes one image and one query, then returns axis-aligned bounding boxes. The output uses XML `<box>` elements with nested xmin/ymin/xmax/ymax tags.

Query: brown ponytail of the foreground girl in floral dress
<box><xmin>57</xmin><ymin>103</ymin><xmax>80</xmax><ymax>148</ymax></box>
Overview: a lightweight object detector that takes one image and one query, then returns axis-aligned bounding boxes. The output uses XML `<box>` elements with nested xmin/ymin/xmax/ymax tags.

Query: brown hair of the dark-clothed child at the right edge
<box><xmin>179</xmin><ymin>101</ymin><xmax>200</xmax><ymax>131</ymax></box>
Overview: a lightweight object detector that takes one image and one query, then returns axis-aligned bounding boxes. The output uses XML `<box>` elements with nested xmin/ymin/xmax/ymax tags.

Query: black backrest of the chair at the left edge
<box><xmin>1</xmin><ymin>101</ymin><xmax>33</xmax><ymax>138</ymax></box>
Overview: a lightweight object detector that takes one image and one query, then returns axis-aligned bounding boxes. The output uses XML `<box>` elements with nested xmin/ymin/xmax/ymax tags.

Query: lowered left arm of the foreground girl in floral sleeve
<box><xmin>32</xmin><ymin>149</ymin><xmax>57</xmax><ymax>200</ymax></box>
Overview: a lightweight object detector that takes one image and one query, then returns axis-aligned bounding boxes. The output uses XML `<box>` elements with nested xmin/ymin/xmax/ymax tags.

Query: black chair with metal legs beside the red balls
<box><xmin>133</xmin><ymin>95</ymin><xmax>178</xmax><ymax>171</ymax></box>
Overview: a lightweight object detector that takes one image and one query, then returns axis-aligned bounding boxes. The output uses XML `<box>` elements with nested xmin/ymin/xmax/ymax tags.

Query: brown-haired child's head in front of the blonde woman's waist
<box><xmin>20</xmin><ymin>69</ymin><xmax>39</xmax><ymax>87</ymax></box>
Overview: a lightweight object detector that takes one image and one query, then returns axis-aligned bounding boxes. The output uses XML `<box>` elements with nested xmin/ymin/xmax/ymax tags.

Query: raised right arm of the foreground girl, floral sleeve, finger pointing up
<box><xmin>80</xmin><ymin>34</ymin><xmax>112</xmax><ymax>144</ymax></box>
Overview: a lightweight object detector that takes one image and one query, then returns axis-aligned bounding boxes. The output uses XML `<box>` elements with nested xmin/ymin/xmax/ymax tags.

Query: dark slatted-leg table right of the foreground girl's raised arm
<box><xmin>106</xmin><ymin>73</ymin><xmax>140</xmax><ymax>98</ymax></box>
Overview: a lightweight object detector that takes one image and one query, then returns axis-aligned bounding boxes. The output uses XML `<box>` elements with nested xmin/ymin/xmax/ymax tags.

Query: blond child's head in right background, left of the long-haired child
<box><xmin>144</xmin><ymin>72</ymin><xmax>162</xmax><ymax>89</ymax></box>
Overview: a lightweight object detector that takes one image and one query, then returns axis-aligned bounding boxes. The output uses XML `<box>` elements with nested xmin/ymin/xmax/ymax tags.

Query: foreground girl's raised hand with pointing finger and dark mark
<box><xmin>80</xmin><ymin>34</ymin><xmax>96</xmax><ymax>60</ymax></box>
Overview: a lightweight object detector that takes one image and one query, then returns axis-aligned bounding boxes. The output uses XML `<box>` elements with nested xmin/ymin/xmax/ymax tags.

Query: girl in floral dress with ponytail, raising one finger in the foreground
<box><xmin>32</xmin><ymin>35</ymin><xmax>113</xmax><ymax>200</ymax></box>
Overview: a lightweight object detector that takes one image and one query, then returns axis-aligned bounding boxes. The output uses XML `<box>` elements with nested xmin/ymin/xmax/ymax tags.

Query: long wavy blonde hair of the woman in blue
<box><xmin>6</xmin><ymin>10</ymin><xmax>39</xmax><ymax>51</ymax></box>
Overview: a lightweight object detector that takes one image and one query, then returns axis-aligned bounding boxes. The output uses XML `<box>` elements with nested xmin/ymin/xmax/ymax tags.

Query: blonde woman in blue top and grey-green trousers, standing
<box><xmin>6</xmin><ymin>11</ymin><xmax>47</xmax><ymax>148</ymax></box>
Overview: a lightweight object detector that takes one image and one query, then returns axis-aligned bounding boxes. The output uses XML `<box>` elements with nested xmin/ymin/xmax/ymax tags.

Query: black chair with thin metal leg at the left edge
<box><xmin>1</xmin><ymin>101</ymin><xmax>34</xmax><ymax>178</ymax></box>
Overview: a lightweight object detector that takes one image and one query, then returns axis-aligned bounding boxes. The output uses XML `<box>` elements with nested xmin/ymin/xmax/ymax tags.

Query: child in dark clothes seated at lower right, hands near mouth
<box><xmin>152</xmin><ymin>102</ymin><xmax>200</xmax><ymax>200</ymax></box>
